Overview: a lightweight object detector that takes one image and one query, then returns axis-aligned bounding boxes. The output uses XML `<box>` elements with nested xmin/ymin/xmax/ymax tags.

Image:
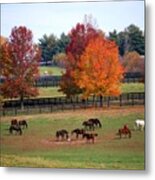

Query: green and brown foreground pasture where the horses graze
<box><xmin>0</xmin><ymin>106</ymin><xmax>144</xmax><ymax>170</ymax></box>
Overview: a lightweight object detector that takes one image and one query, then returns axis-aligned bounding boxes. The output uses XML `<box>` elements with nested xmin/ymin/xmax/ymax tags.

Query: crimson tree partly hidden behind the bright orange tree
<box><xmin>60</xmin><ymin>23</ymin><xmax>100</xmax><ymax>97</ymax></box>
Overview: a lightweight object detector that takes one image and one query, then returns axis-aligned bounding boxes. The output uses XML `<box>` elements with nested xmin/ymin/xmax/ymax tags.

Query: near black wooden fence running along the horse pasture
<box><xmin>0</xmin><ymin>92</ymin><xmax>145</xmax><ymax>116</ymax></box>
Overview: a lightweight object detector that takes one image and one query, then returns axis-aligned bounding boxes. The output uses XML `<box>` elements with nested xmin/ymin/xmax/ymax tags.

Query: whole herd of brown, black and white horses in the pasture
<box><xmin>9</xmin><ymin>118</ymin><xmax>145</xmax><ymax>143</ymax></box>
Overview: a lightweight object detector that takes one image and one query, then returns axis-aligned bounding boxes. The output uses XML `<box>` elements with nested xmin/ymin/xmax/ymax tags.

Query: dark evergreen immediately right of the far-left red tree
<box><xmin>39</xmin><ymin>34</ymin><xmax>59</xmax><ymax>65</ymax></box>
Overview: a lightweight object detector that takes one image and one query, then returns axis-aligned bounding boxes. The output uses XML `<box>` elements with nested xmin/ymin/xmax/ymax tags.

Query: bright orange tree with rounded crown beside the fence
<box><xmin>72</xmin><ymin>35</ymin><xmax>123</xmax><ymax>106</ymax></box>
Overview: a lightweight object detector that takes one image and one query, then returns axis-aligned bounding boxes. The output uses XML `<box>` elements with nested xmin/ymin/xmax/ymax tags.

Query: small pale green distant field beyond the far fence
<box><xmin>39</xmin><ymin>66</ymin><xmax>65</xmax><ymax>76</ymax></box>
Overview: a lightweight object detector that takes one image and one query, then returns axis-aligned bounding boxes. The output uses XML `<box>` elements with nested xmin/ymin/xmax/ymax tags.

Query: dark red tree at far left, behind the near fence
<box><xmin>0</xmin><ymin>26</ymin><xmax>41</xmax><ymax>109</ymax></box>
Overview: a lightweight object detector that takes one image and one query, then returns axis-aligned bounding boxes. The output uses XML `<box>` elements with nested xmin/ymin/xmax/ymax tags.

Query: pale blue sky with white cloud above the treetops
<box><xmin>1</xmin><ymin>1</ymin><xmax>145</xmax><ymax>42</ymax></box>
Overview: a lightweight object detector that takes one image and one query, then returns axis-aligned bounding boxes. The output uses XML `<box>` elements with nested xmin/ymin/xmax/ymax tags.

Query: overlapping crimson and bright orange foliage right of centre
<box><xmin>61</xmin><ymin>23</ymin><xmax>123</xmax><ymax>98</ymax></box>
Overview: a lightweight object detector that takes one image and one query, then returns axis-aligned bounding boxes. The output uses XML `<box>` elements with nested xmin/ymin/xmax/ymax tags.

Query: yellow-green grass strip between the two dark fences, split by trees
<box><xmin>39</xmin><ymin>83</ymin><xmax>144</xmax><ymax>97</ymax></box>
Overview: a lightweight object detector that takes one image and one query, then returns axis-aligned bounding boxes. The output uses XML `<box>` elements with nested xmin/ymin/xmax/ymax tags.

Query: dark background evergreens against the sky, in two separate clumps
<box><xmin>39</xmin><ymin>24</ymin><xmax>145</xmax><ymax>66</ymax></box>
